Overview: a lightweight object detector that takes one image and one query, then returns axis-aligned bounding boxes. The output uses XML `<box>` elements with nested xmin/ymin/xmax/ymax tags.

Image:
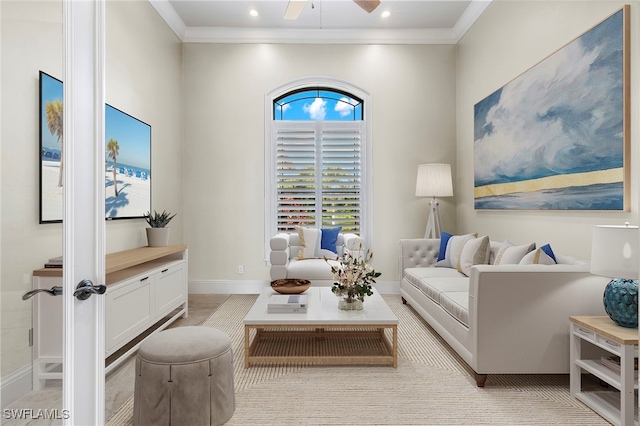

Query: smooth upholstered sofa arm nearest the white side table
<box><xmin>469</xmin><ymin>264</ymin><xmax>609</xmax><ymax>374</ymax></box>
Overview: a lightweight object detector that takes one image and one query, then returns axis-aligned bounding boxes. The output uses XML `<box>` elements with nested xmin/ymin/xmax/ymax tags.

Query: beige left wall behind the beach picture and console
<box><xmin>0</xmin><ymin>1</ymin><xmax>183</xmax><ymax>378</ymax></box>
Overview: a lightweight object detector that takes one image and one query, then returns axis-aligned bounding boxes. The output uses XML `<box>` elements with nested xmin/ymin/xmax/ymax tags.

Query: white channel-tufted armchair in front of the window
<box><xmin>269</xmin><ymin>233</ymin><xmax>364</xmax><ymax>286</ymax></box>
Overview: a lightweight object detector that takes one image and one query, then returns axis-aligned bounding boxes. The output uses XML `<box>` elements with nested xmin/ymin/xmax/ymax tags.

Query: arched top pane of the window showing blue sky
<box><xmin>273</xmin><ymin>89</ymin><xmax>362</xmax><ymax>121</ymax></box>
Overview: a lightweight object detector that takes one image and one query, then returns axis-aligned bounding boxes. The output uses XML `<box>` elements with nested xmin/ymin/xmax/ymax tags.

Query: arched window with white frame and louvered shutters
<box><xmin>265</xmin><ymin>82</ymin><xmax>370</xmax><ymax>251</ymax></box>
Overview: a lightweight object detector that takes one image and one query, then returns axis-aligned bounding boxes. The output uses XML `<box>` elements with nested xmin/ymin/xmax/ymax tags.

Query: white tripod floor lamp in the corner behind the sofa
<box><xmin>416</xmin><ymin>164</ymin><xmax>453</xmax><ymax>238</ymax></box>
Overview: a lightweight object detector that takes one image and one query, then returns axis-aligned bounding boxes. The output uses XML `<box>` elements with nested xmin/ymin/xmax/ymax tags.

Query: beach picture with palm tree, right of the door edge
<box><xmin>104</xmin><ymin>104</ymin><xmax>151</xmax><ymax>220</ymax></box>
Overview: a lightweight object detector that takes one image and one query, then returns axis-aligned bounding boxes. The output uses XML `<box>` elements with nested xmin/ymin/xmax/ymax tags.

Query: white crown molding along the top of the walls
<box><xmin>148</xmin><ymin>0</ymin><xmax>492</xmax><ymax>44</ymax></box>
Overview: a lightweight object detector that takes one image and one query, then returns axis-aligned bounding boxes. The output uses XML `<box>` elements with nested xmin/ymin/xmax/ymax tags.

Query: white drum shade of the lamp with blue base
<box><xmin>591</xmin><ymin>225</ymin><xmax>640</xmax><ymax>280</ymax></box>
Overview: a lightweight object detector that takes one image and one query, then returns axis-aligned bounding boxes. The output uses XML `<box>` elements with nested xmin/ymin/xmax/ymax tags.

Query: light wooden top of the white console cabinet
<box><xmin>33</xmin><ymin>245</ymin><xmax>187</xmax><ymax>277</ymax></box>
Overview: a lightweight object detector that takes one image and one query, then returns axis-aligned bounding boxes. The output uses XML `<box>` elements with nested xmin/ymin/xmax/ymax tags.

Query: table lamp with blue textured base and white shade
<box><xmin>591</xmin><ymin>223</ymin><xmax>640</xmax><ymax>328</ymax></box>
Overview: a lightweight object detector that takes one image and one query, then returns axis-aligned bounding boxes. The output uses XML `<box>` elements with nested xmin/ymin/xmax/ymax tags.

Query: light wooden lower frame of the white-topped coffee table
<box><xmin>244</xmin><ymin>324</ymin><xmax>398</xmax><ymax>368</ymax></box>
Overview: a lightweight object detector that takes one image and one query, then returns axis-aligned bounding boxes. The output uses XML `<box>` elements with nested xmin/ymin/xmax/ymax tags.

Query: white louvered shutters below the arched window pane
<box><xmin>274</xmin><ymin>121</ymin><xmax>362</xmax><ymax>233</ymax></box>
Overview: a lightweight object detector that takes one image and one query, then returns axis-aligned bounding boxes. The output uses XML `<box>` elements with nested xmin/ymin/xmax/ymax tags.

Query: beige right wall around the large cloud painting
<box><xmin>455</xmin><ymin>0</ymin><xmax>639</xmax><ymax>258</ymax></box>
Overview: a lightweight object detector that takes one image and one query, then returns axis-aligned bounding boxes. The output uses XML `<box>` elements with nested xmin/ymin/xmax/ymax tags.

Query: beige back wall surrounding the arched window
<box><xmin>183</xmin><ymin>44</ymin><xmax>455</xmax><ymax>282</ymax></box>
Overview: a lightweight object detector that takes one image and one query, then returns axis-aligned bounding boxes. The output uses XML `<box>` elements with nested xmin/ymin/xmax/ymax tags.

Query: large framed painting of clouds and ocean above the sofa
<box><xmin>474</xmin><ymin>6</ymin><xmax>630</xmax><ymax>211</ymax></box>
